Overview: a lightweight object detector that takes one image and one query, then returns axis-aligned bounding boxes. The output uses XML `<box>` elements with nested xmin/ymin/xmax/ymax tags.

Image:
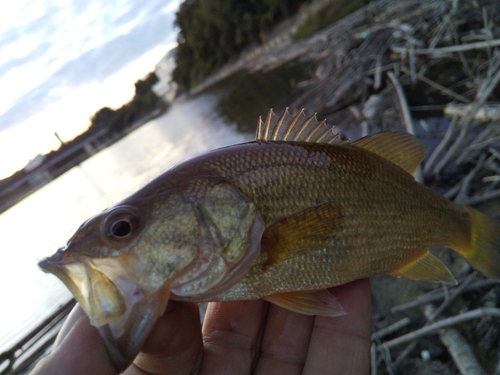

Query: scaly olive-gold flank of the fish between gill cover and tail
<box><xmin>167</xmin><ymin>142</ymin><xmax>467</xmax><ymax>300</ymax></box>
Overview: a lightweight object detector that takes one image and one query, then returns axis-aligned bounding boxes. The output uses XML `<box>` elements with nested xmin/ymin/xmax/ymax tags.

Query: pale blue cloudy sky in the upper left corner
<box><xmin>0</xmin><ymin>0</ymin><xmax>181</xmax><ymax>179</ymax></box>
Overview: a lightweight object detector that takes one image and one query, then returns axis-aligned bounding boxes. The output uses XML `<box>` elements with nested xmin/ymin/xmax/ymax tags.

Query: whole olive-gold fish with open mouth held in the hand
<box><xmin>39</xmin><ymin>110</ymin><xmax>500</xmax><ymax>369</ymax></box>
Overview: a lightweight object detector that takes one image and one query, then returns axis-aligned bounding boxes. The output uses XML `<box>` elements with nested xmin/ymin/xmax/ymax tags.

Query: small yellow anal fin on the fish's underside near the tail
<box><xmin>390</xmin><ymin>251</ymin><xmax>457</xmax><ymax>285</ymax></box>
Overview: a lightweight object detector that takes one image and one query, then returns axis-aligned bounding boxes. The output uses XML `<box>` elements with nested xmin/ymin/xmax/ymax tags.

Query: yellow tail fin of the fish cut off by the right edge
<box><xmin>460</xmin><ymin>206</ymin><xmax>500</xmax><ymax>279</ymax></box>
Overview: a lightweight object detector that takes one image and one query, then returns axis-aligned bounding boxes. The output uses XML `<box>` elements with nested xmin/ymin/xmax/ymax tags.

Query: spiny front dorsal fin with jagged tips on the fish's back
<box><xmin>255</xmin><ymin>108</ymin><xmax>342</xmax><ymax>144</ymax></box>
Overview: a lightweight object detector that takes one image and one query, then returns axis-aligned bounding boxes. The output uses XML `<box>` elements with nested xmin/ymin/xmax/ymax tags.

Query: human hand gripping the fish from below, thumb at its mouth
<box><xmin>32</xmin><ymin>279</ymin><xmax>371</xmax><ymax>375</ymax></box>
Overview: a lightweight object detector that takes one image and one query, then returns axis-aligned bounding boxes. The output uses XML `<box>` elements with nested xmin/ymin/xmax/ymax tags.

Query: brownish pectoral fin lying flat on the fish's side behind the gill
<box><xmin>261</xmin><ymin>202</ymin><xmax>342</xmax><ymax>266</ymax></box>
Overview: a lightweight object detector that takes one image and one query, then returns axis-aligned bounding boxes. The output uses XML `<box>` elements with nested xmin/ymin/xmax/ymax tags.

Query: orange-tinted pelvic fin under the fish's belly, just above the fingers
<box><xmin>263</xmin><ymin>289</ymin><xmax>347</xmax><ymax>317</ymax></box>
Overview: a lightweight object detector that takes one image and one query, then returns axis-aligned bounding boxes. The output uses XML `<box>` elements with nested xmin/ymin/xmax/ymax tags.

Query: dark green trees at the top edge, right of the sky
<box><xmin>173</xmin><ymin>0</ymin><xmax>310</xmax><ymax>90</ymax></box>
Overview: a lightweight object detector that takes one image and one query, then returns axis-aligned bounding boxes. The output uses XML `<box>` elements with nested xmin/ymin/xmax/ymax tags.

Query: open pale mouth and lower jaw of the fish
<box><xmin>38</xmin><ymin>249</ymin><xmax>170</xmax><ymax>371</ymax></box>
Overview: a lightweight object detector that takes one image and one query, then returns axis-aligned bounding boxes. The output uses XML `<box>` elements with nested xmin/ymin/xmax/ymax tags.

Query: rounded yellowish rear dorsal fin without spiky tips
<box><xmin>352</xmin><ymin>132</ymin><xmax>427</xmax><ymax>174</ymax></box>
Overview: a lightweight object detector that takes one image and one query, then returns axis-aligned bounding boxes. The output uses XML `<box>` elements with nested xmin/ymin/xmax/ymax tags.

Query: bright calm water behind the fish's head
<box><xmin>0</xmin><ymin>95</ymin><xmax>253</xmax><ymax>352</ymax></box>
